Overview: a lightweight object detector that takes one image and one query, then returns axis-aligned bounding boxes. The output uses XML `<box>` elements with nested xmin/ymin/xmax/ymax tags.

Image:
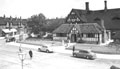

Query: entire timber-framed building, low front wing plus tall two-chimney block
<box><xmin>53</xmin><ymin>1</ymin><xmax>115</xmax><ymax>43</ymax></box>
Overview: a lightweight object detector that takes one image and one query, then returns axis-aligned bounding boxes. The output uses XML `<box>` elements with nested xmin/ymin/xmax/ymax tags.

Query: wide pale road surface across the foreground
<box><xmin>0</xmin><ymin>40</ymin><xmax>120</xmax><ymax>69</ymax></box>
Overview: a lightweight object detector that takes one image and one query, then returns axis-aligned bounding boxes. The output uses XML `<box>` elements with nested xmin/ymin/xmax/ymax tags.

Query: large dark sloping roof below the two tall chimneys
<box><xmin>67</xmin><ymin>8</ymin><xmax>120</xmax><ymax>29</ymax></box>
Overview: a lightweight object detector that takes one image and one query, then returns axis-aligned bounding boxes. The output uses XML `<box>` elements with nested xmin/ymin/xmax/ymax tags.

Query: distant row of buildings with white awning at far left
<box><xmin>0</xmin><ymin>15</ymin><xmax>26</xmax><ymax>40</ymax></box>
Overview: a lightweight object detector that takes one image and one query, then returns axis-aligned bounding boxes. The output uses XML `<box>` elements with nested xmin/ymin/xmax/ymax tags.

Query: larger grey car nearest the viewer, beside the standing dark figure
<box><xmin>73</xmin><ymin>50</ymin><xmax>96</xmax><ymax>59</ymax></box>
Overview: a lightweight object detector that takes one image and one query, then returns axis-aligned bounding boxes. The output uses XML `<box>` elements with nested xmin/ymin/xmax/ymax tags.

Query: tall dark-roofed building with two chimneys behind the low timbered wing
<box><xmin>65</xmin><ymin>1</ymin><xmax>120</xmax><ymax>38</ymax></box>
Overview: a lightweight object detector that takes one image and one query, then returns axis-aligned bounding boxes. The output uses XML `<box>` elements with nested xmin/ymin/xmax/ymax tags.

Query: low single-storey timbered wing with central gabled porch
<box><xmin>53</xmin><ymin>23</ymin><xmax>111</xmax><ymax>44</ymax></box>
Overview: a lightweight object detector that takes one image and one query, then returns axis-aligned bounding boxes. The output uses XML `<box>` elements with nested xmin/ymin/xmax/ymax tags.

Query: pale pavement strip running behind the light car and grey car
<box><xmin>6</xmin><ymin>42</ymin><xmax>120</xmax><ymax>59</ymax></box>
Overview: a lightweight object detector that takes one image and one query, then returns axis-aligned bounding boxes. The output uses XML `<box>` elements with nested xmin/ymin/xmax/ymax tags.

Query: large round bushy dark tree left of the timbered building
<box><xmin>27</xmin><ymin>13</ymin><xmax>46</xmax><ymax>34</ymax></box>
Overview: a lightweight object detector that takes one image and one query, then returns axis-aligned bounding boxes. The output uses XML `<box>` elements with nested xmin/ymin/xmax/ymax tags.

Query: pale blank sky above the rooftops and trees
<box><xmin>0</xmin><ymin>0</ymin><xmax>120</xmax><ymax>18</ymax></box>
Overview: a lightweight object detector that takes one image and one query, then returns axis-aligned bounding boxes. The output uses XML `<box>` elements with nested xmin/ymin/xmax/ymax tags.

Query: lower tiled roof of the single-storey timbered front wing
<box><xmin>53</xmin><ymin>23</ymin><xmax>103</xmax><ymax>33</ymax></box>
